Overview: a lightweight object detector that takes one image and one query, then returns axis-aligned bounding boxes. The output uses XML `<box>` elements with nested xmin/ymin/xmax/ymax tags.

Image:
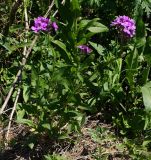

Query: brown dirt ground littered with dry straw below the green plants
<box><xmin>0</xmin><ymin>117</ymin><xmax>130</xmax><ymax>160</ymax></box>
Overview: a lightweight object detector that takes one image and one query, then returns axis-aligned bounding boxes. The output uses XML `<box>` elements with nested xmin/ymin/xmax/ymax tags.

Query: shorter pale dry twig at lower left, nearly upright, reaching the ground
<box><xmin>6</xmin><ymin>88</ymin><xmax>21</xmax><ymax>141</ymax></box>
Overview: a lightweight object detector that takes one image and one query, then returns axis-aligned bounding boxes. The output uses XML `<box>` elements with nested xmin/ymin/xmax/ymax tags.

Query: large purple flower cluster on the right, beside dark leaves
<box><xmin>111</xmin><ymin>16</ymin><xmax>136</xmax><ymax>38</ymax></box>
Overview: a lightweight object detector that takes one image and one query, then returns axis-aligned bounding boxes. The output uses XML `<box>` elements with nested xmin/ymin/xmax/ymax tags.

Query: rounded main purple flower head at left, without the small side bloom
<box><xmin>31</xmin><ymin>17</ymin><xmax>50</xmax><ymax>33</ymax></box>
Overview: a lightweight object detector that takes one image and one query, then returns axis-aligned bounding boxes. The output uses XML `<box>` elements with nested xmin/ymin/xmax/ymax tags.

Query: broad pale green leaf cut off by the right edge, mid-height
<box><xmin>141</xmin><ymin>82</ymin><xmax>151</xmax><ymax>111</ymax></box>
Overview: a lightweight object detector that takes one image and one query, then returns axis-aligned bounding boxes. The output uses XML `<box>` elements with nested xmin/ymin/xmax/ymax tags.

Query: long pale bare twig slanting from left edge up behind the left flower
<box><xmin>0</xmin><ymin>0</ymin><xmax>54</xmax><ymax>115</ymax></box>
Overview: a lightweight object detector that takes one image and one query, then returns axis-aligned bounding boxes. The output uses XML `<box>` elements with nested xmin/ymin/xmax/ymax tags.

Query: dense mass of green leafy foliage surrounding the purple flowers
<box><xmin>0</xmin><ymin>0</ymin><xmax>151</xmax><ymax>159</ymax></box>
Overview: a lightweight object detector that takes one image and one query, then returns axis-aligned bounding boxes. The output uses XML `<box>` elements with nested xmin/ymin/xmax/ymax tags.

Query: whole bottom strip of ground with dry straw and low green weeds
<box><xmin>0</xmin><ymin>114</ymin><xmax>151</xmax><ymax>160</ymax></box>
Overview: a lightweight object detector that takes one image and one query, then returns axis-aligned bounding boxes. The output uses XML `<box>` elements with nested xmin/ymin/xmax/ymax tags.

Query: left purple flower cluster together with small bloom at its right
<box><xmin>31</xmin><ymin>17</ymin><xmax>58</xmax><ymax>33</ymax></box>
